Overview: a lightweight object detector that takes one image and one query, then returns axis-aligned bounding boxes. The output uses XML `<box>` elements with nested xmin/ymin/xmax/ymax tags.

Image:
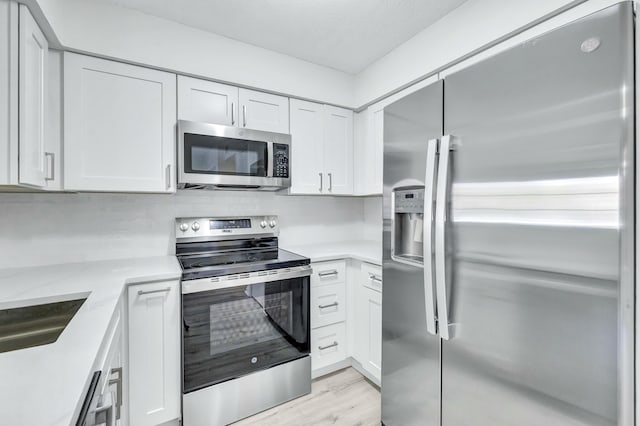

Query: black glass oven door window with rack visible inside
<box><xmin>182</xmin><ymin>277</ymin><xmax>309</xmax><ymax>393</ymax></box>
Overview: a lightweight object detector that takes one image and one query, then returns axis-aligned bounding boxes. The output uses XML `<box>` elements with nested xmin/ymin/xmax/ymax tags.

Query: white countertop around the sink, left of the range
<box><xmin>0</xmin><ymin>256</ymin><xmax>181</xmax><ymax>425</ymax></box>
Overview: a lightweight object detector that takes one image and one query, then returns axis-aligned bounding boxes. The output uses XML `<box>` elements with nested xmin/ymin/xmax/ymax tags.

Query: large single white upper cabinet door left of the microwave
<box><xmin>64</xmin><ymin>53</ymin><xmax>176</xmax><ymax>192</ymax></box>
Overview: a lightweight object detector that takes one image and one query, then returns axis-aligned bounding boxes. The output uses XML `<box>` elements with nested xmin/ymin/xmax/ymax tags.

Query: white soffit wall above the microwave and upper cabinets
<box><xmin>27</xmin><ymin>0</ymin><xmax>354</xmax><ymax>107</ymax></box>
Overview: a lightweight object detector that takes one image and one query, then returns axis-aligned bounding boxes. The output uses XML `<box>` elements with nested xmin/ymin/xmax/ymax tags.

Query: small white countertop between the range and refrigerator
<box><xmin>282</xmin><ymin>240</ymin><xmax>382</xmax><ymax>265</ymax></box>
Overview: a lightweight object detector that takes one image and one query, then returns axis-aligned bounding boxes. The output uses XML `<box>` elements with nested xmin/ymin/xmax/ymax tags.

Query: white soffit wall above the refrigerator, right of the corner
<box><xmin>354</xmin><ymin>0</ymin><xmax>584</xmax><ymax>106</ymax></box>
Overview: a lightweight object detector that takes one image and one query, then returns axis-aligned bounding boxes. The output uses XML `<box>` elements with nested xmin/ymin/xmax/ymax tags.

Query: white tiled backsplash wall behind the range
<box><xmin>0</xmin><ymin>191</ymin><xmax>374</xmax><ymax>268</ymax></box>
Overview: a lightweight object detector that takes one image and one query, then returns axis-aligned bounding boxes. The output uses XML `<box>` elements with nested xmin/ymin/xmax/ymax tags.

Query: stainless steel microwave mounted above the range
<box><xmin>178</xmin><ymin>120</ymin><xmax>291</xmax><ymax>191</ymax></box>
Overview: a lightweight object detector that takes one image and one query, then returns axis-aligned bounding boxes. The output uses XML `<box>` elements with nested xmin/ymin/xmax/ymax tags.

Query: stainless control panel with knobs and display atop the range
<box><xmin>176</xmin><ymin>216</ymin><xmax>280</xmax><ymax>241</ymax></box>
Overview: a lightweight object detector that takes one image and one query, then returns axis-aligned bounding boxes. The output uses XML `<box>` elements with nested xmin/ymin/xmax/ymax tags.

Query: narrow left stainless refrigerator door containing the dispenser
<box><xmin>382</xmin><ymin>81</ymin><xmax>442</xmax><ymax>426</ymax></box>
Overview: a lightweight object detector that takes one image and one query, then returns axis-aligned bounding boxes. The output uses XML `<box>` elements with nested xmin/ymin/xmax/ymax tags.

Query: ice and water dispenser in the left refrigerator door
<box><xmin>391</xmin><ymin>186</ymin><xmax>424</xmax><ymax>265</ymax></box>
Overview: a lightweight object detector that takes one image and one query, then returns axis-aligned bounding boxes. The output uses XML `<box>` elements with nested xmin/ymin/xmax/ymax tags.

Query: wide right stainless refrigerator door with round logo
<box><xmin>442</xmin><ymin>2</ymin><xmax>635</xmax><ymax>426</ymax></box>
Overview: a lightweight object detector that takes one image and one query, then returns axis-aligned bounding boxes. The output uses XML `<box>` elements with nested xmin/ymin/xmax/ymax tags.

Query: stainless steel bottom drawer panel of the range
<box><xmin>182</xmin><ymin>356</ymin><xmax>311</xmax><ymax>426</ymax></box>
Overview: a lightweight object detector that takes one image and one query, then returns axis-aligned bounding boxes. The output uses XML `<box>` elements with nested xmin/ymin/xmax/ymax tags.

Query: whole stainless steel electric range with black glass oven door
<box><xmin>176</xmin><ymin>216</ymin><xmax>311</xmax><ymax>426</ymax></box>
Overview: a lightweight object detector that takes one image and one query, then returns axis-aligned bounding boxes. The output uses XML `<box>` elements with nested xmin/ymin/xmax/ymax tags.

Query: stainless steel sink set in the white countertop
<box><xmin>0</xmin><ymin>298</ymin><xmax>87</xmax><ymax>353</ymax></box>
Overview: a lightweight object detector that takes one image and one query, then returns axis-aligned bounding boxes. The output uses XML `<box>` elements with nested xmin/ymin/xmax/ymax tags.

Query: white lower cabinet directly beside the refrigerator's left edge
<box><xmin>353</xmin><ymin>263</ymin><xmax>382</xmax><ymax>383</ymax></box>
